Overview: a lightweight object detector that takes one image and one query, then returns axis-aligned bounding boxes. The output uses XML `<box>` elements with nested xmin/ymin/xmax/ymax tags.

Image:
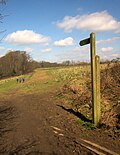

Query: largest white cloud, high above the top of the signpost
<box><xmin>56</xmin><ymin>11</ymin><xmax>120</xmax><ymax>33</ymax></box>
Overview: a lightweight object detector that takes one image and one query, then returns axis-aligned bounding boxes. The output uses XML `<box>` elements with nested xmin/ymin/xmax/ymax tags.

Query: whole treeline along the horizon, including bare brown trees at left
<box><xmin>0</xmin><ymin>51</ymin><xmax>120</xmax><ymax>79</ymax></box>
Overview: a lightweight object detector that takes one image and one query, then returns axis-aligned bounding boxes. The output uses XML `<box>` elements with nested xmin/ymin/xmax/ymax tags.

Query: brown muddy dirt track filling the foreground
<box><xmin>0</xmin><ymin>93</ymin><xmax>120</xmax><ymax>155</ymax></box>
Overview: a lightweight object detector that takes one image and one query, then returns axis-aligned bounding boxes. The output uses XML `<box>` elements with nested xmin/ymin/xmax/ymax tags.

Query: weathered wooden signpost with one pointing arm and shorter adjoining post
<box><xmin>79</xmin><ymin>33</ymin><xmax>101</xmax><ymax>126</ymax></box>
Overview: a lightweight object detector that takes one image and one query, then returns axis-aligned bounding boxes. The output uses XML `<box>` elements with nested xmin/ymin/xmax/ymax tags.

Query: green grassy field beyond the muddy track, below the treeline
<box><xmin>0</xmin><ymin>66</ymin><xmax>89</xmax><ymax>93</ymax></box>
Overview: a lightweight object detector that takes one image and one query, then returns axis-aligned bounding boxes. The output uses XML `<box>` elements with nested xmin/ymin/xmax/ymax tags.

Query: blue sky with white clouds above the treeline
<box><xmin>0</xmin><ymin>0</ymin><xmax>120</xmax><ymax>62</ymax></box>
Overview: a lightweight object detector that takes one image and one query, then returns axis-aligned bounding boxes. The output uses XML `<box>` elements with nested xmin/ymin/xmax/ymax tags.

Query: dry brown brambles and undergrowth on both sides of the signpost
<box><xmin>53</xmin><ymin>62</ymin><xmax>120</xmax><ymax>129</ymax></box>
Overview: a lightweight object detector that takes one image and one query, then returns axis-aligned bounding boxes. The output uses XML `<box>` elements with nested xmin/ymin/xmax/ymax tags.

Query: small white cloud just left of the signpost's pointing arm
<box><xmin>54</xmin><ymin>37</ymin><xmax>74</xmax><ymax>47</ymax></box>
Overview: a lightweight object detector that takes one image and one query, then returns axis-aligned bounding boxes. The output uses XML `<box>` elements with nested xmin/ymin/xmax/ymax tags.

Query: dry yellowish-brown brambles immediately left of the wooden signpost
<box><xmin>53</xmin><ymin>65</ymin><xmax>91</xmax><ymax>118</ymax></box>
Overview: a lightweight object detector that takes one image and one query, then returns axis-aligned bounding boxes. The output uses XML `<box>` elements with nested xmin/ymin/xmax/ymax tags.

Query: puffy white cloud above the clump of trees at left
<box><xmin>5</xmin><ymin>30</ymin><xmax>50</xmax><ymax>45</ymax></box>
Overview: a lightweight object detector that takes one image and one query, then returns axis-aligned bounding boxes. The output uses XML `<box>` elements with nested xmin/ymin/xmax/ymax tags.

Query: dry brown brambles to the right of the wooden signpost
<box><xmin>101</xmin><ymin>62</ymin><xmax>120</xmax><ymax>129</ymax></box>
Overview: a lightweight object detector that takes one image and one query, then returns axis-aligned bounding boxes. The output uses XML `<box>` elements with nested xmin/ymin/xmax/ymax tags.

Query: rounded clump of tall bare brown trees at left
<box><xmin>0</xmin><ymin>51</ymin><xmax>37</xmax><ymax>78</ymax></box>
